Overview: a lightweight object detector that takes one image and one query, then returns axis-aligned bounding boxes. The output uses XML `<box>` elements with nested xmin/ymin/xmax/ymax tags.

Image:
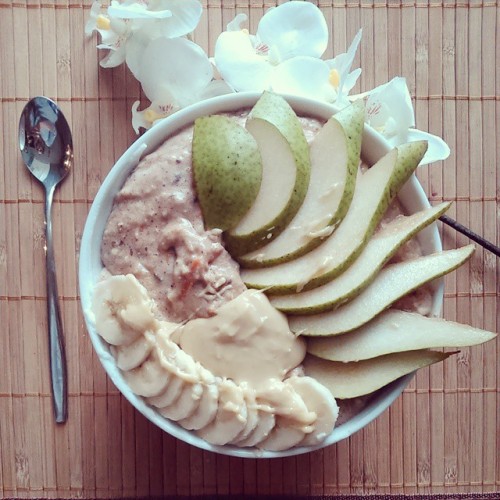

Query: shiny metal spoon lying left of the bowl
<box><xmin>19</xmin><ymin>97</ymin><xmax>73</xmax><ymax>423</ymax></box>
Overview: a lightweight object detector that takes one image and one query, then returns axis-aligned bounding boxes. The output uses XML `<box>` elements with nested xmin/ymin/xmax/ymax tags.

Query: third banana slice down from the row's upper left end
<box><xmin>123</xmin><ymin>349</ymin><xmax>172</xmax><ymax>397</ymax></box>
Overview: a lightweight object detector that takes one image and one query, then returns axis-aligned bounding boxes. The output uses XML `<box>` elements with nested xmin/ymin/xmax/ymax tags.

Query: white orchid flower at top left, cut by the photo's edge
<box><xmin>85</xmin><ymin>0</ymin><xmax>203</xmax><ymax>71</ymax></box>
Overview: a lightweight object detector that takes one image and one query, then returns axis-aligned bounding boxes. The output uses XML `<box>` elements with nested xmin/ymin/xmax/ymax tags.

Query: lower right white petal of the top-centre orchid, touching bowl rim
<box><xmin>271</xmin><ymin>56</ymin><xmax>336</xmax><ymax>102</ymax></box>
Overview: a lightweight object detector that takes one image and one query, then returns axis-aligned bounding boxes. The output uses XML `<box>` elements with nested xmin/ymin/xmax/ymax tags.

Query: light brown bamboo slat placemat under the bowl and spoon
<box><xmin>0</xmin><ymin>0</ymin><xmax>500</xmax><ymax>498</ymax></box>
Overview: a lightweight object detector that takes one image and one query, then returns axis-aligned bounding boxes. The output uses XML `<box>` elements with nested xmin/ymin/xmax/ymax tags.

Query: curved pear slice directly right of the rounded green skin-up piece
<box><xmin>225</xmin><ymin>92</ymin><xmax>311</xmax><ymax>257</ymax></box>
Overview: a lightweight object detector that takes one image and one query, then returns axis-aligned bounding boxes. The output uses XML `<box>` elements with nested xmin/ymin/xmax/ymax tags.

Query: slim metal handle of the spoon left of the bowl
<box><xmin>45</xmin><ymin>186</ymin><xmax>68</xmax><ymax>423</ymax></box>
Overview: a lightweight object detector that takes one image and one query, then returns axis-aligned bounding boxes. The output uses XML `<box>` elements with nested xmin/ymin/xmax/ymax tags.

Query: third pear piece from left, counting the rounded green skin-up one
<box><xmin>238</xmin><ymin>100</ymin><xmax>365</xmax><ymax>268</ymax></box>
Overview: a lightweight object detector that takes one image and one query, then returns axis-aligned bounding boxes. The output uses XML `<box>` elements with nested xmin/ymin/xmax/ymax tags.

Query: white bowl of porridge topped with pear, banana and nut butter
<box><xmin>79</xmin><ymin>93</ymin><xmax>452</xmax><ymax>458</ymax></box>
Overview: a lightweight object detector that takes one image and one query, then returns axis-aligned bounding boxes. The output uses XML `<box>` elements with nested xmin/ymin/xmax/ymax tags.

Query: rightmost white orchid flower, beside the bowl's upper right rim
<box><xmin>364</xmin><ymin>77</ymin><xmax>450</xmax><ymax>165</ymax></box>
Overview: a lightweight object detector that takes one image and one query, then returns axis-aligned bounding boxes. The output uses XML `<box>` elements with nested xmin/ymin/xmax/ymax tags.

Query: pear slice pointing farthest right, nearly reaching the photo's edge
<box><xmin>307</xmin><ymin>309</ymin><xmax>497</xmax><ymax>362</ymax></box>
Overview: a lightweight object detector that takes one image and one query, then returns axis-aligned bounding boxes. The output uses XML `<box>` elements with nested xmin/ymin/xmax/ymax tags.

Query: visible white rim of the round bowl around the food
<box><xmin>79</xmin><ymin>93</ymin><xmax>443</xmax><ymax>458</ymax></box>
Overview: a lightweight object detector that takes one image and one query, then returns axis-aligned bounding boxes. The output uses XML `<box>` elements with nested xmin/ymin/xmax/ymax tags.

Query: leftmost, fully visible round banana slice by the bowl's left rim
<box><xmin>92</xmin><ymin>274</ymin><xmax>158</xmax><ymax>345</ymax></box>
